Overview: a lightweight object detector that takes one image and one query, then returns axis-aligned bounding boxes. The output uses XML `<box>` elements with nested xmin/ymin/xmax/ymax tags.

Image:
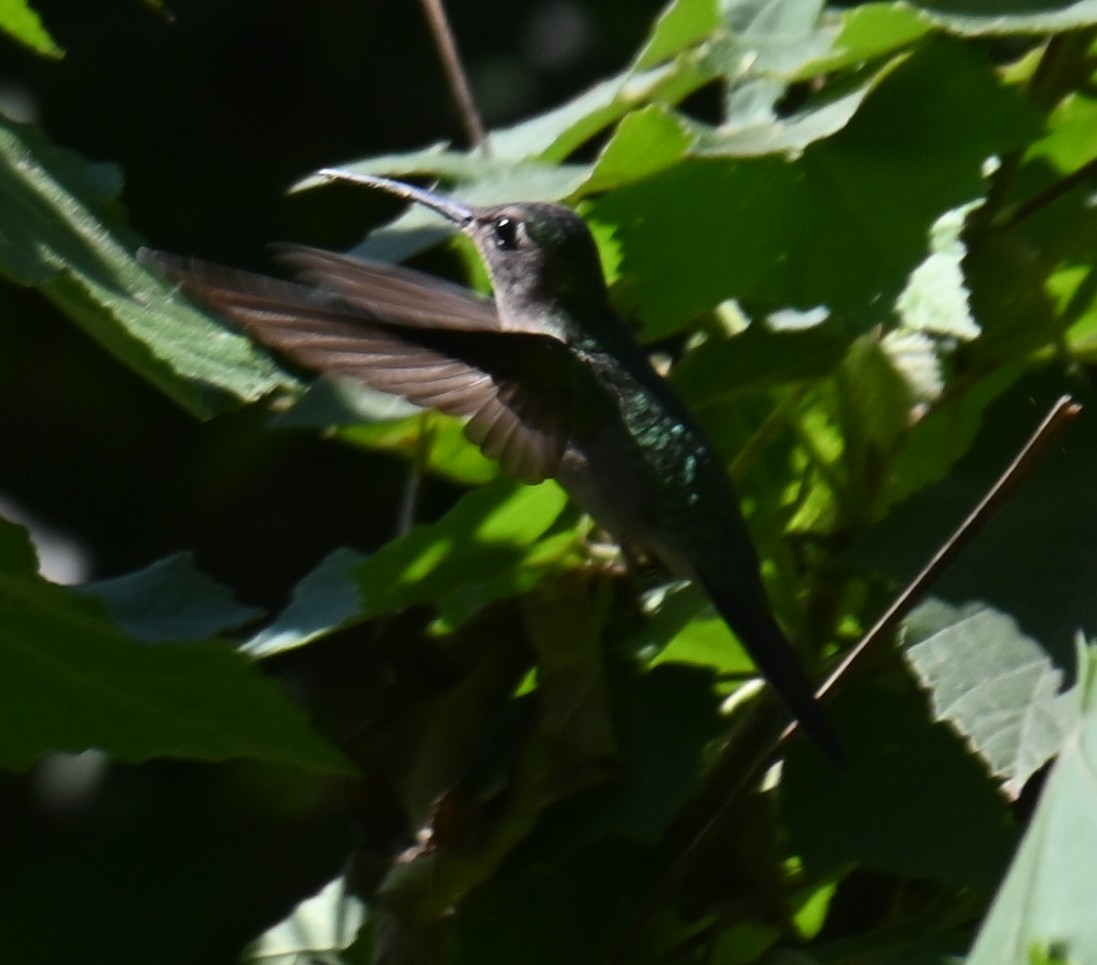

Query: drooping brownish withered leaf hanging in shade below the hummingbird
<box><xmin>382</xmin><ymin>574</ymin><xmax>617</xmax><ymax>921</ymax></box>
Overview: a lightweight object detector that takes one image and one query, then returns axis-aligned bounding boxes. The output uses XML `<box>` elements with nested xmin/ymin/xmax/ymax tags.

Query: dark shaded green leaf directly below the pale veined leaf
<box><xmin>781</xmin><ymin>681</ymin><xmax>1016</xmax><ymax>889</ymax></box>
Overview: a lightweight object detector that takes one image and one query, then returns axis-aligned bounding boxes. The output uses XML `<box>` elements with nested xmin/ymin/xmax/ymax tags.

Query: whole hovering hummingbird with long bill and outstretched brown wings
<box><xmin>139</xmin><ymin>169</ymin><xmax>840</xmax><ymax>758</ymax></box>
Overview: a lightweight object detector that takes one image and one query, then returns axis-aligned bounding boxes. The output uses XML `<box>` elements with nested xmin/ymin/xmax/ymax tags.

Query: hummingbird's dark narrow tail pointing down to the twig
<box><xmin>700</xmin><ymin>578</ymin><xmax>845</xmax><ymax>761</ymax></box>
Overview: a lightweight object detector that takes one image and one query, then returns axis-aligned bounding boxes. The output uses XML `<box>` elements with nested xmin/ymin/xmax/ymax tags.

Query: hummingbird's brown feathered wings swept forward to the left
<box><xmin>140</xmin><ymin>249</ymin><xmax>598</xmax><ymax>483</ymax></box>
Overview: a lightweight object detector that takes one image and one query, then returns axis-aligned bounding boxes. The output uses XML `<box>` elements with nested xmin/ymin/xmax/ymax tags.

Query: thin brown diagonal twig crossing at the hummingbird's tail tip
<box><xmin>613</xmin><ymin>396</ymin><xmax>1082</xmax><ymax>965</ymax></box>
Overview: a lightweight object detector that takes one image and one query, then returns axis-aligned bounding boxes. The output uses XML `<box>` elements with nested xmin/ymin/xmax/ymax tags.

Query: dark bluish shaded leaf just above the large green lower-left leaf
<box><xmin>79</xmin><ymin>553</ymin><xmax>263</xmax><ymax>643</ymax></box>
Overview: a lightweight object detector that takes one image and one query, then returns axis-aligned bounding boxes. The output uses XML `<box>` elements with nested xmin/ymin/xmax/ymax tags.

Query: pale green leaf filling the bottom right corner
<box><xmin>966</xmin><ymin>650</ymin><xmax>1097</xmax><ymax>965</ymax></box>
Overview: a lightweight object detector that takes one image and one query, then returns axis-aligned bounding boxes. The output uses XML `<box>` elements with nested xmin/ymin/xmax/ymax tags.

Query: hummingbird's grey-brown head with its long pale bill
<box><xmin>320</xmin><ymin>170</ymin><xmax>608</xmax><ymax>339</ymax></box>
